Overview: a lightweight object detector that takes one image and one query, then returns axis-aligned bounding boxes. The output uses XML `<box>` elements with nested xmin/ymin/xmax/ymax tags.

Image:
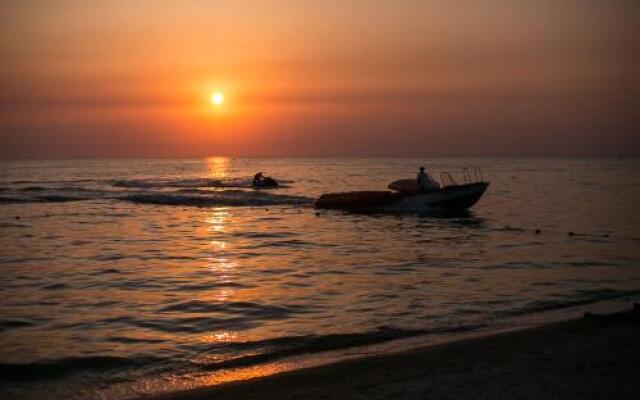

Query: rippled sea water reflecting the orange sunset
<box><xmin>0</xmin><ymin>157</ymin><xmax>640</xmax><ymax>400</ymax></box>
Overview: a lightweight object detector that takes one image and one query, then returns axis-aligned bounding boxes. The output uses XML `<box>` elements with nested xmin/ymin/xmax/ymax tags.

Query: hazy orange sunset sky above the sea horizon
<box><xmin>0</xmin><ymin>0</ymin><xmax>640</xmax><ymax>159</ymax></box>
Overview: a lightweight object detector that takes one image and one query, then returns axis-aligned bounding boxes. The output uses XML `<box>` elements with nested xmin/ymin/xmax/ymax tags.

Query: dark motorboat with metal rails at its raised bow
<box><xmin>315</xmin><ymin>168</ymin><xmax>489</xmax><ymax>213</ymax></box>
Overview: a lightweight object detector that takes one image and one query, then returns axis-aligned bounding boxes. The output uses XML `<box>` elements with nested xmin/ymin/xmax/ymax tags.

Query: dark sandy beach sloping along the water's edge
<box><xmin>145</xmin><ymin>305</ymin><xmax>640</xmax><ymax>400</ymax></box>
